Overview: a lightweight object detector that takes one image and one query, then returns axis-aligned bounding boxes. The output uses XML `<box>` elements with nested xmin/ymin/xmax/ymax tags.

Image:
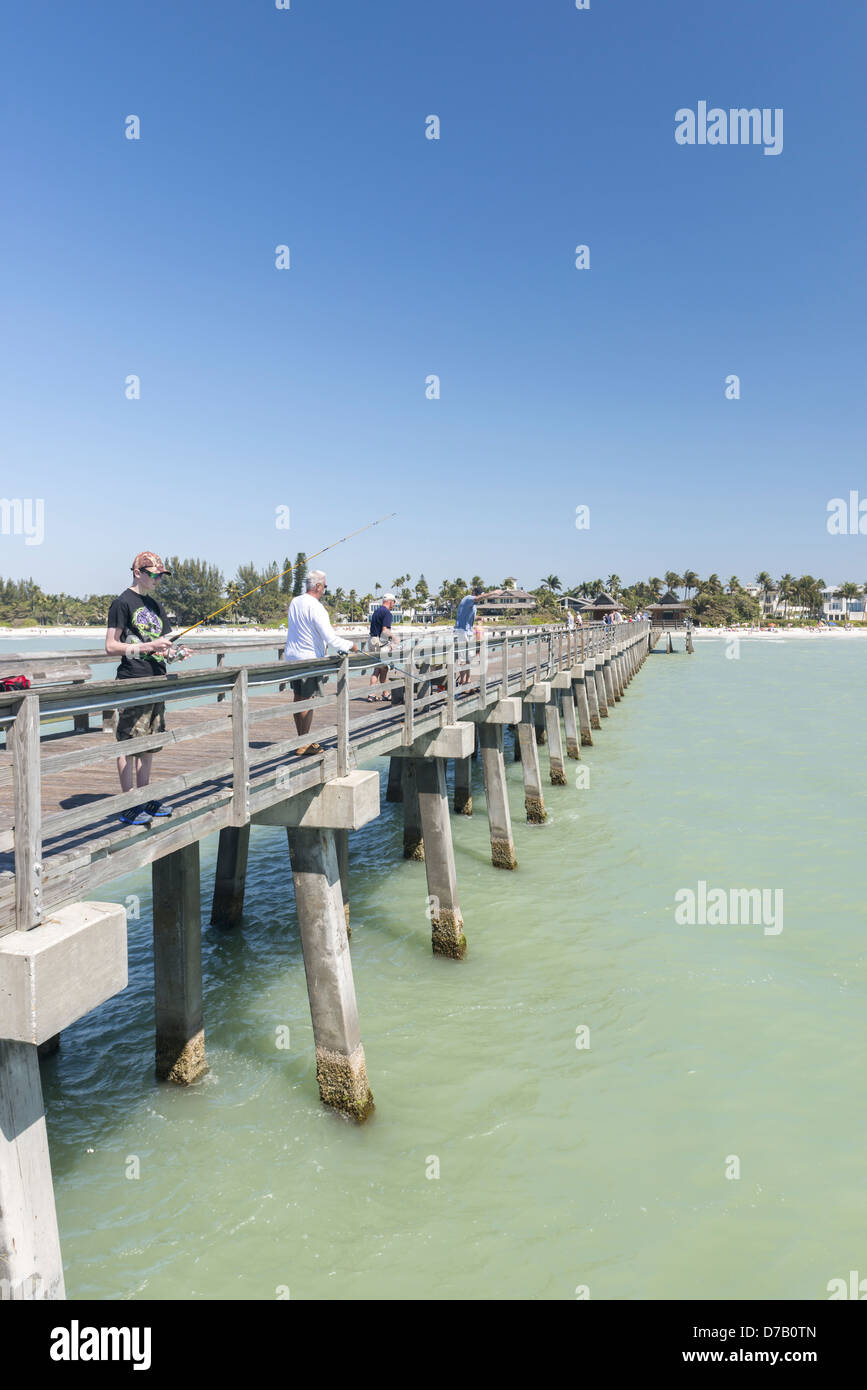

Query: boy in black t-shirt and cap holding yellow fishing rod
<box><xmin>106</xmin><ymin>550</ymin><xmax>172</xmax><ymax>826</ymax></box>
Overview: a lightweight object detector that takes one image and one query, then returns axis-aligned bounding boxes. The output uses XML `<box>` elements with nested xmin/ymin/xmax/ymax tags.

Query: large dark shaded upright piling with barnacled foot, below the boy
<box><xmin>151</xmin><ymin>840</ymin><xmax>206</xmax><ymax>1086</ymax></box>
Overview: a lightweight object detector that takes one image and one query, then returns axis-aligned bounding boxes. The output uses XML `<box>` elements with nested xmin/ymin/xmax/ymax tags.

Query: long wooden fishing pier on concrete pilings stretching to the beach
<box><xmin>0</xmin><ymin>620</ymin><xmax>661</xmax><ymax>1298</ymax></box>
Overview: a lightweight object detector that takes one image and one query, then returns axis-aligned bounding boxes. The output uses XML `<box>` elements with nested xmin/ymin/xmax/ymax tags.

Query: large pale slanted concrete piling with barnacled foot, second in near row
<box><xmin>286</xmin><ymin>828</ymin><xmax>374</xmax><ymax>1122</ymax></box>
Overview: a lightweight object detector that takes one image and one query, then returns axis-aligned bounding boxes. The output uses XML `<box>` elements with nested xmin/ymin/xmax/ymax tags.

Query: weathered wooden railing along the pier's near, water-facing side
<box><xmin>0</xmin><ymin>621</ymin><xmax>649</xmax><ymax>934</ymax></box>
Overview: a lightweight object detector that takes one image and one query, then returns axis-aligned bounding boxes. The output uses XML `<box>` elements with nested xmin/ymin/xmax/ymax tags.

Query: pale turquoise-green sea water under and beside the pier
<box><xmin>25</xmin><ymin>639</ymin><xmax>867</xmax><ymax>1300</ymax></box>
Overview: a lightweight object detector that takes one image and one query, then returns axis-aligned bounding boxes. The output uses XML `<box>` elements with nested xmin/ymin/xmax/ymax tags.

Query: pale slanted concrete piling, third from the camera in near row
<box><xmin>413</xmin><ymin>758</ymin><xmax>467</xmax><ymax>960</ymax></box>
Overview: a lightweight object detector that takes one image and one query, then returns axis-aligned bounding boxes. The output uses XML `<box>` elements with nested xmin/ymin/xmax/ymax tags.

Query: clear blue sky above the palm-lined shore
<box><xmin>0</xmin><ymin>0</ymin><xmax>867</xmax><ymax>594</ymax></box>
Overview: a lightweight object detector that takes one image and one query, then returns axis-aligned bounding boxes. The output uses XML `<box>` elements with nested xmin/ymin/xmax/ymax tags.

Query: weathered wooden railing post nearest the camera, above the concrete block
<box><xmin>10</xmin><ymin>695</ymin><xmax>42</xmax><ymax>931</ymax></box>
